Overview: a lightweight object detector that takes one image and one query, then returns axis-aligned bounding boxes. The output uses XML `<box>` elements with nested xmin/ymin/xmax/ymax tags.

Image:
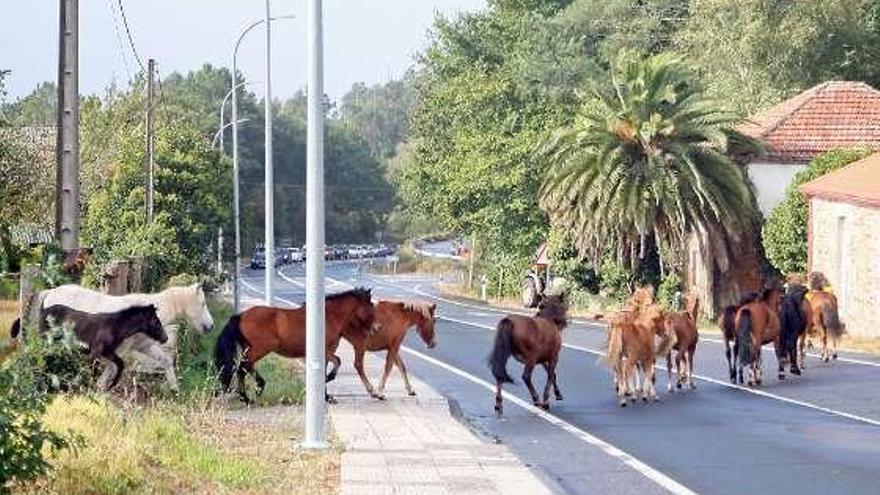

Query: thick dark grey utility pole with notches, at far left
<box><xmin>55</xmin><ymin>0</ymin><xmax>79</xmax><ymax>251</ymax></box>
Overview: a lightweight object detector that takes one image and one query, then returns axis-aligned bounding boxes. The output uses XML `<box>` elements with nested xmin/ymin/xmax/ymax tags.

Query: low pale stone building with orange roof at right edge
<box><xmin>800</xmin><ymin>153</ymin><xmax>880</xmax><ymax>337</ymax></box>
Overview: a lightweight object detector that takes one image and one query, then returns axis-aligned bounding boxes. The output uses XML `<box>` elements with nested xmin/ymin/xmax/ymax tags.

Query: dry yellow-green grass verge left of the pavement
<box><xmin>16</xmin><ymin>396</ymin><xmax>339</xmax><ymax>494</ymax></box>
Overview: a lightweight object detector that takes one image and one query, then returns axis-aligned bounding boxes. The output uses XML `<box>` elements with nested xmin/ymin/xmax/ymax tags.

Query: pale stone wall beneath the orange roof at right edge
<box><xmin>810</xmin><ymin>198</ymin><xmax>880</xmax><ymax>337</ymax></box>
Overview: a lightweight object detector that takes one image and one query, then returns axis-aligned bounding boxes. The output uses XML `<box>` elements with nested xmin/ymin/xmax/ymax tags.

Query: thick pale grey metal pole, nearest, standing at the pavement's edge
<box><xmin>303</xmin><ymin>0</ymin><xmax>327</xmax><ymax>449</ymax></box>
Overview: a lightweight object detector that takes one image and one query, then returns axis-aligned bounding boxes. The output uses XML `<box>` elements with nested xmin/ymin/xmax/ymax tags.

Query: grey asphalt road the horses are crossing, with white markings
<box><xmin>237</xmin><ymin>263</ymin><xmax>880</xmax><ymax>495</ymax></box>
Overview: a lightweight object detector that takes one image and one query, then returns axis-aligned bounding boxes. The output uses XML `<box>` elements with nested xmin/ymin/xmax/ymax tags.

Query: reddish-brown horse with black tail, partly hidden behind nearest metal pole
<box><xmin>214</xmin><ymin>288</ymin><xmax>375</xmax><ymax>403</ymax></box>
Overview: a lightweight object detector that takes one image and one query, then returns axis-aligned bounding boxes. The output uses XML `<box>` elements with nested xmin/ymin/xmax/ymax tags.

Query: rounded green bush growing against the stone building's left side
<box><xmin>763</xmin><ymin>149</ymin><xmax>871</xmax><ymax>274</ymax></box>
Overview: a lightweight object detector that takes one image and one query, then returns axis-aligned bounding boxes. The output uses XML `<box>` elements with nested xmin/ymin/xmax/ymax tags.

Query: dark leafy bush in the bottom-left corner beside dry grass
<box><xmin>0</xmin><ymin>328</ymin><xmax>86</xmax><ymax>493</ymax></box>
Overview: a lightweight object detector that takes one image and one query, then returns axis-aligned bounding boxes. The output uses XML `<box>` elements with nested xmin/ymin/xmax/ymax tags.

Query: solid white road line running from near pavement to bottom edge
<box><xmin>402</xmin><ymin>346</ymin><xmax>696</xmax><ymax>495</ymax></box>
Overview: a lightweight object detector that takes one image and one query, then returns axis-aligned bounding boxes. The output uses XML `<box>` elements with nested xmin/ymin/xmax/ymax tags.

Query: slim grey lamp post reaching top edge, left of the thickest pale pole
<box><xmin>263</xmin><ymin>0</ymin><xmax>275</xmax><ymax>306</ymax></box>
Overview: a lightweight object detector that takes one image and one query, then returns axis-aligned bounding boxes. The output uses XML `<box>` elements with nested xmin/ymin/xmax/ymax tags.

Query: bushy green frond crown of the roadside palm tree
<box><xmin>540</xmin><ymin>53</ymin><xmax>756</xmax><ymax>274</ymax></box>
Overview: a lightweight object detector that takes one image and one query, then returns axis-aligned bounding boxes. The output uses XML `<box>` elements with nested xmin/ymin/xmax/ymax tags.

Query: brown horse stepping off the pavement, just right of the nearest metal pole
<box><xmin>348</xmin><ymin>301</ymin><xmax>437</xmax><ymax>400</ymax></box>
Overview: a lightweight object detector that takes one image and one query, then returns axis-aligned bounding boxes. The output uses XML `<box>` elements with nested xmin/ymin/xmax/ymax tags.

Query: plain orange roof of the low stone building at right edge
<box><xmin>799</xmin><ymin>153</ymin><xmax>880</xmax><ymax>208</ymax></box>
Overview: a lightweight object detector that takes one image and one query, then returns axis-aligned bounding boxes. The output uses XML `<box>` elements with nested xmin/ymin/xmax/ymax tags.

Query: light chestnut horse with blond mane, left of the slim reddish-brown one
<box><xmin>605</xmin><ymin>304</ymin><xmax>674</xmax><ymax>407</ymax></box>
